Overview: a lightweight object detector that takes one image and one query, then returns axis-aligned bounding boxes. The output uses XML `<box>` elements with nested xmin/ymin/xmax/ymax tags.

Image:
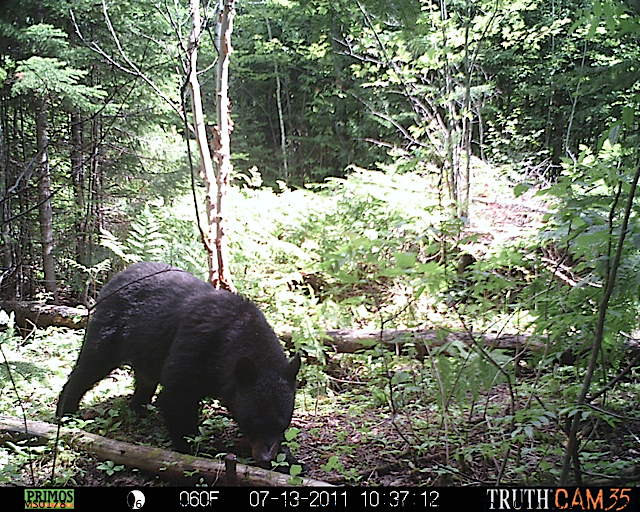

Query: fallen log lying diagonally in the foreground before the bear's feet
<box><xmin>0</xmin><ymin>416</ymin><xmax>331</xmax><ymax>487</ymax></box>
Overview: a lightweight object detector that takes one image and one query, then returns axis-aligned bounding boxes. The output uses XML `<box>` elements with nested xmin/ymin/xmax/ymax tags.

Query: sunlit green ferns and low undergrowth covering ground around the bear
<box><xmin>0</xmin><ymin>169</ymin><xmax>640</xmax><ymax>485</ymax></box>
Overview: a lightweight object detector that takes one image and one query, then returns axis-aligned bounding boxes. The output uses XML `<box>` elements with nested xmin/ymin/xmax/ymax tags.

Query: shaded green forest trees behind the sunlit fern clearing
<box><xmin>0</xmin><ymin>1</ymin><xmax>637</xmax><ymax>298</ymax></box>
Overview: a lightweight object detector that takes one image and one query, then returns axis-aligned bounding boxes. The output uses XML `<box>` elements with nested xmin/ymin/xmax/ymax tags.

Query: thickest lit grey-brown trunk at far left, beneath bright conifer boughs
<box><xmin>36</xmin><ymin>99</ymin><xmax>58</xmax><ymax>303</ymax></box>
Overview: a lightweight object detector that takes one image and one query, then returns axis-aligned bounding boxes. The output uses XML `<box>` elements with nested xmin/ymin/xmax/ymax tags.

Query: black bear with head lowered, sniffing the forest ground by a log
<box><xmin>57</xmin><ymin>263</ymin><xmax>300</xmax><ymax>465</ymax></box>
